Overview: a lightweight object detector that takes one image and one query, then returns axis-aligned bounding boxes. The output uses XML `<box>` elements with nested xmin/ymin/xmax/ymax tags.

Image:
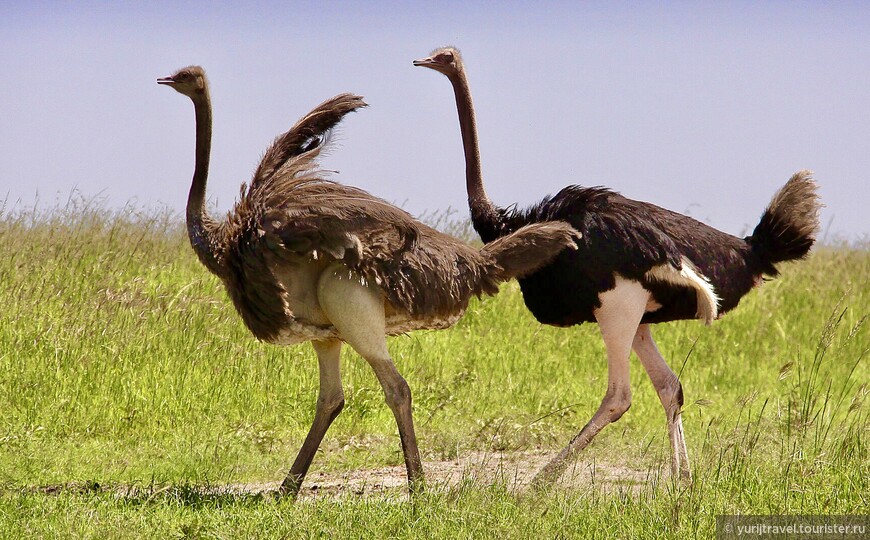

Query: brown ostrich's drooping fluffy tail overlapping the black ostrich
<box><xmin>480</xmin><ymin>221</ymin><xmax>580</xmax><ymax>281</ymax></box>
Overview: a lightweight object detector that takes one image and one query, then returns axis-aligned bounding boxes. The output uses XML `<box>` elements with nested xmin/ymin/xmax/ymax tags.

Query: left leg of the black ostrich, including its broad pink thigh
<box><xmin>532</xmin><ymin>277</ymin><xmax>649</xmax><ymax>488</ymax></box>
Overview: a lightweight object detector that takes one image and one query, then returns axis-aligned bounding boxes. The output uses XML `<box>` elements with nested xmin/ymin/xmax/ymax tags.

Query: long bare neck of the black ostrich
<box><xmin>449</xmin><ymin>70</ymin><xmax>500</xmax><ymax>238</ymax></box>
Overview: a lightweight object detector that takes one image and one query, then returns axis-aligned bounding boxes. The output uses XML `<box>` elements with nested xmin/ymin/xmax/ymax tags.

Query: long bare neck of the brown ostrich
<box><xmin>187</xmin><ymin>88</ymin><xmax>220</xmax><ymax>274</ymax></box>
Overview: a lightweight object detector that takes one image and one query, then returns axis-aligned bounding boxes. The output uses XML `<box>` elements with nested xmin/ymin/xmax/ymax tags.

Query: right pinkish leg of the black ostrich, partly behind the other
<box><xmin>632</xmin><ymin>324</ymin><xmax>692</xmax><ymax>481</ymax></box>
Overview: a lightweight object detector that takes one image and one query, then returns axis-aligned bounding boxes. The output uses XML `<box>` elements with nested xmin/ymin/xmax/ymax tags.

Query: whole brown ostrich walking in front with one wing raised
<box><xmin>158</xmin><ymin>66</ymin><xmax>576</xmax><ymax>494</ymax></box>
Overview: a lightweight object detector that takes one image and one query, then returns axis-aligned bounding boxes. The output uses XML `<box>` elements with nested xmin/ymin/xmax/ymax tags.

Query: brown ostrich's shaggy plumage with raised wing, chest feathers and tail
<box><xmin>212</xmin><ymin>94</ymin><xmax>577</xmax><ymax>340</ymax></box>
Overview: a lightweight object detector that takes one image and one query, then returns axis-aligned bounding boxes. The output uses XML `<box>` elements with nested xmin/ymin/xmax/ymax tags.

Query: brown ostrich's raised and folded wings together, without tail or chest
<box><xmin>231</xmin><ymin>94</ymin><xmax>497</xmax><ymax>322</ymax></box>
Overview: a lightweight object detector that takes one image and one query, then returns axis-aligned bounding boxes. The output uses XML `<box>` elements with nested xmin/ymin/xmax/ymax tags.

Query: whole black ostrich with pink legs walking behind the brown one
<box><xmin>414</xmin><ymin>47</ymin><xmax>821</xmax><ymax>485</ymax></box>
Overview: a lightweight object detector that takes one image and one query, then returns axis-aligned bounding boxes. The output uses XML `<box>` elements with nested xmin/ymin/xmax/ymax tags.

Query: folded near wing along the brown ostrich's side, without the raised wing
<box><xmin>260</xmin><ymin>180</ymin><xmax>498</xmax><ymax>316</ymax></box>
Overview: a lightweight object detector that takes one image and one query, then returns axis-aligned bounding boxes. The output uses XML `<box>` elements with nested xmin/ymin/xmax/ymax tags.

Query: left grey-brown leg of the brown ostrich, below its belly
<box><xmin>278</xmin><ymin>340</ymin><xmax>344</xmax><ymax>497</ymax></box>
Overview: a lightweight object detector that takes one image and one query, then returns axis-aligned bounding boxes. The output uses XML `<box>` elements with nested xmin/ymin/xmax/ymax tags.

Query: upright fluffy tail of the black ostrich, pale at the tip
<box><xmin>746</xmin><ymin>171</ymin><xmax>822</xmax><ymax>276</ymax></box>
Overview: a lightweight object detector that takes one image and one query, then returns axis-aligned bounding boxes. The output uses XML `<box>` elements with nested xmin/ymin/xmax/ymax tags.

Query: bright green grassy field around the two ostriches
<box><xmin>0</xmin><ymin>202</ymin><xmax>870</xmax><ymax>538</ymax></box>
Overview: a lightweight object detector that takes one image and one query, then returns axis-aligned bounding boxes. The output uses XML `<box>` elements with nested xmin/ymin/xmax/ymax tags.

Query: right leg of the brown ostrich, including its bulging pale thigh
<box><xmin>317</xmin><ymin>264</ymin><xmax>423</xmax><ymax>492</ymax></box>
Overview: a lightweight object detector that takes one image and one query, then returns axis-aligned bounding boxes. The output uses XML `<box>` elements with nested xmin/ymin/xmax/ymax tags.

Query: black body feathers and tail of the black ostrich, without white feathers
<box><xmin>480</xmin><ymin>178</ymin><xmax>818</xmax><ymax>326</ymax></box>
